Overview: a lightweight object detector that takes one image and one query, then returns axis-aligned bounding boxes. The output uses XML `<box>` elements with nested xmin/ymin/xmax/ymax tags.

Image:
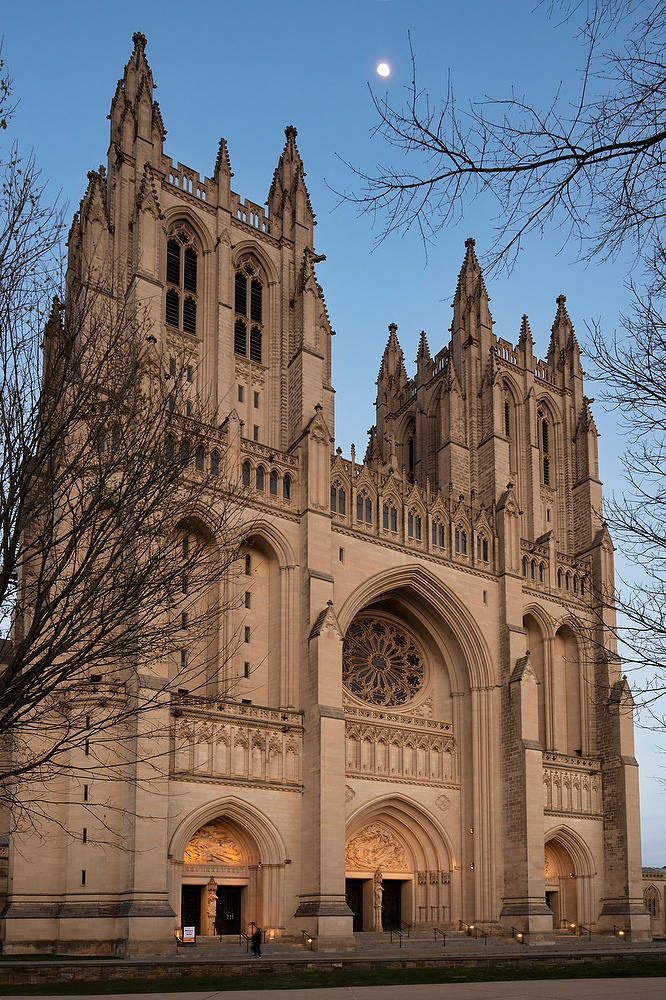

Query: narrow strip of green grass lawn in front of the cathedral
<box><xmin>0</xmin><ymin>959</ymin><xmax>666</xmax><ymax>996</ymax></box>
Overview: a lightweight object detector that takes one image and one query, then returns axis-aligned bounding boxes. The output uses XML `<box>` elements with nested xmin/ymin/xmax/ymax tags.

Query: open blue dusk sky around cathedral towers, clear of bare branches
<box><xmin>2</xmin><ymin>0</ymin><xmax>666</xmax><ymax>865</ymax></box>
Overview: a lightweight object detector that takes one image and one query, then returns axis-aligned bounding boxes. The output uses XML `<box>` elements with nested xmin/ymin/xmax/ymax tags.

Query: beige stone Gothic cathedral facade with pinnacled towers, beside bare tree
<box><xmin>2</xmin><ymin>34</ymin><xmax>649</xmax><ymax>952</ymax></box>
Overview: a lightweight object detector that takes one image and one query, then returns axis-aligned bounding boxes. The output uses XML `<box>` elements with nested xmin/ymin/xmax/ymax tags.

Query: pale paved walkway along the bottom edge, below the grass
<box><xmin>0</xmin><ymin>978</ymin><xmax>666</xmax><ymax>1000</ymax></box>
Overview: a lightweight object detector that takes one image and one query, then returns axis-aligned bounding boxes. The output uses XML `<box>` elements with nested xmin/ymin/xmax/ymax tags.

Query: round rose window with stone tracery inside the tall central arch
<box><xmin>342</xmin><ymin>618</ymin><xmax>423</xmax><ymax>708</ymax></box>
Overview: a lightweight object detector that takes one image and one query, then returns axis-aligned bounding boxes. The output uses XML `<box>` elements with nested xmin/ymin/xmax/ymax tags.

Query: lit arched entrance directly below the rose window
<box><xmin>345</xmin><ymin>796</ymin><xmax>454</xmax><ymax>931</ymax></box>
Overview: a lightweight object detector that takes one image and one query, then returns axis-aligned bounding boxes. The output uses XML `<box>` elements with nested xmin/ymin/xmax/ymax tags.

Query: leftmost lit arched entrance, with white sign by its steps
<box><xmin>171</xmin><ymin>799</ymin><xmax>285</xmax><ymax>937</ymax></box>
